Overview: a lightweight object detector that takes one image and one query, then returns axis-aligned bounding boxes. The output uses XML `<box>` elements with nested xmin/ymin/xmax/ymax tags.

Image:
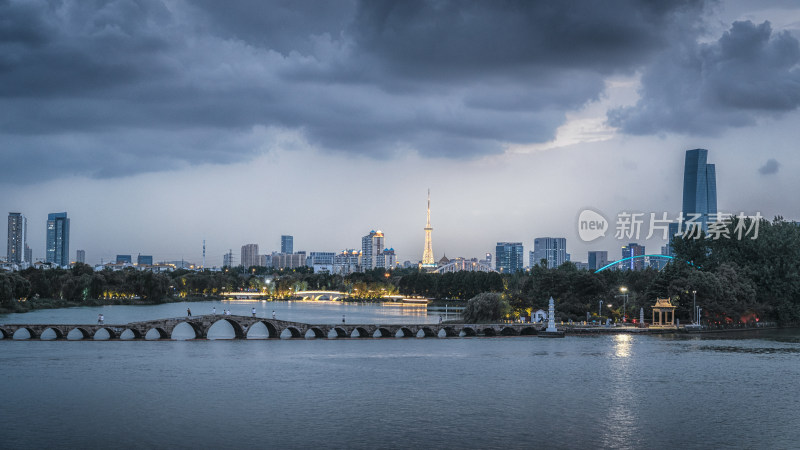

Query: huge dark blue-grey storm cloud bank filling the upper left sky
<box><xmin>0</xmin><ymin>0</ymin><xmax>703</xmax><ymax>181</ymax></box>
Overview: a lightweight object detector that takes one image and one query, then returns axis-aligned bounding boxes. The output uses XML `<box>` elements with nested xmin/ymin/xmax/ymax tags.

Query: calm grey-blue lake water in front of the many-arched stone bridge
<box><xmin>0</xmin><ymin>305</ymin><xmax>800</xmax><ymax>448</ymax></box>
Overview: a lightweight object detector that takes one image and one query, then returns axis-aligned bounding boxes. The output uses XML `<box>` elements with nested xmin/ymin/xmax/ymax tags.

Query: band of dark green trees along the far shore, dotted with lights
<box><xmin>0</xmin><ymin>217</ymin><xmax>800</xmax><ymax>328</ymax></box>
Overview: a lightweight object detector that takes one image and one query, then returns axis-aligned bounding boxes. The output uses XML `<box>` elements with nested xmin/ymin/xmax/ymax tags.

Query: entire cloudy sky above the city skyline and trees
<box><xmin>0</xmin><ymin>0</ymin><xmax>800</xmax><ymax>265</ymax></box>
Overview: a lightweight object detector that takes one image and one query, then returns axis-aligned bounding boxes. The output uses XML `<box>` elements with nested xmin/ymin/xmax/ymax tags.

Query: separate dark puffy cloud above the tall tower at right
<box><xmin>609</xmin><ymin>21</ymin><xmax>800</xmax><ymax>135</ymax></box>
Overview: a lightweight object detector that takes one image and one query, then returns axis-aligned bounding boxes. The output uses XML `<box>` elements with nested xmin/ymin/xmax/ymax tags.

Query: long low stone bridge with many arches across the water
<box><xmin>0</xmin><ymin>314</ymin><xmax>544</xmax><ymax>340</ymax></box>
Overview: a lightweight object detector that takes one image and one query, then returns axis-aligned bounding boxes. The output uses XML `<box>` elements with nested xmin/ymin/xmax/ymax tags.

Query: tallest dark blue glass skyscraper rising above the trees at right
<box><xmin>683</xmin><ymin>148</ymin><xmax>717</xmax><ymax>230</ymax></box>
